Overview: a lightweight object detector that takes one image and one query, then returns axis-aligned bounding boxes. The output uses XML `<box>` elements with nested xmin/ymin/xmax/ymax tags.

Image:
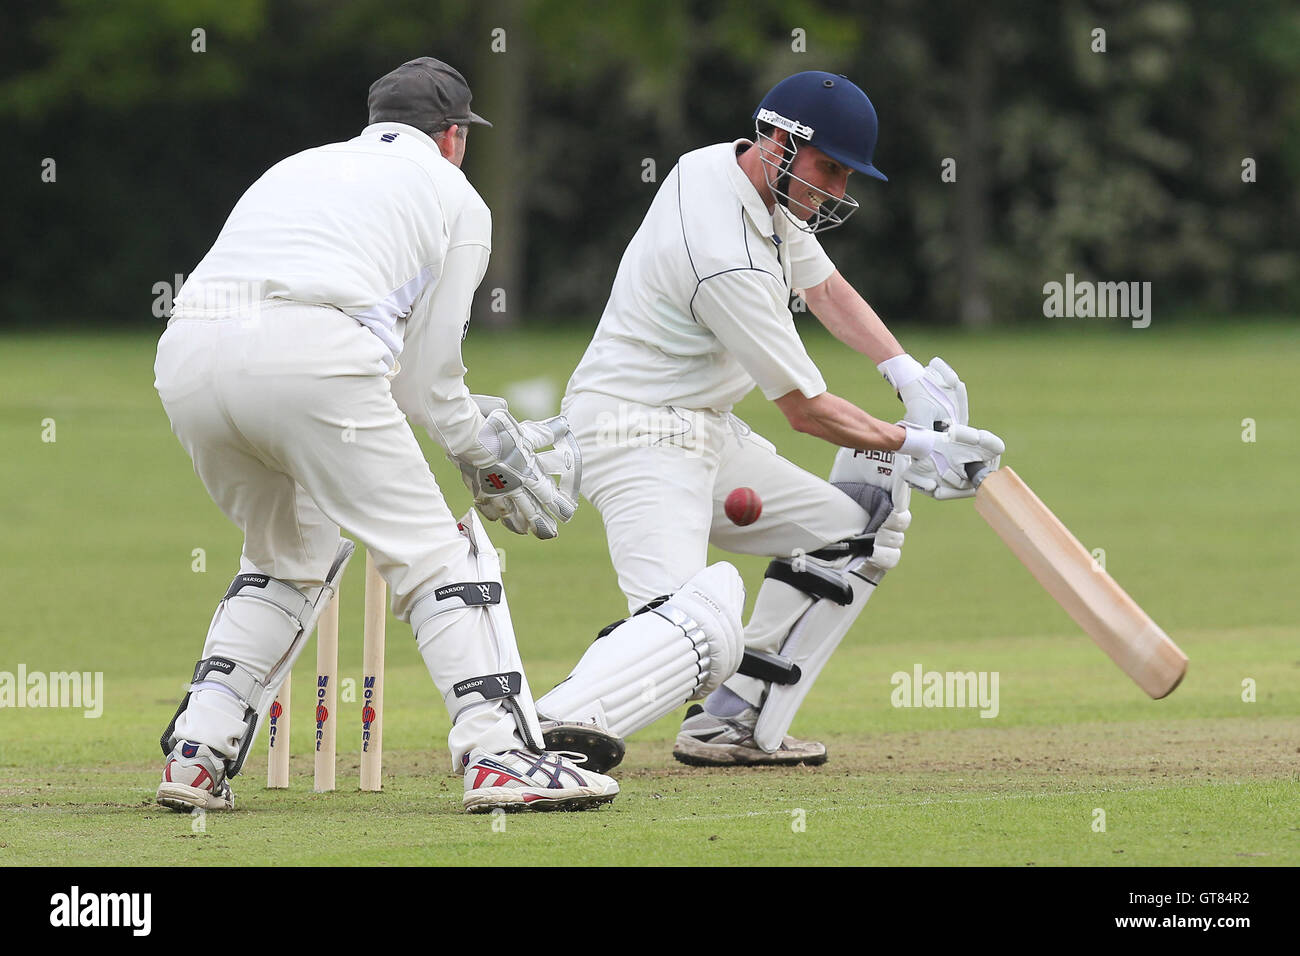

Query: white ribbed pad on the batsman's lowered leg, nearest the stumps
<box><xmin>537</xmin><ymin>561</ymin><xmax>745</xmax><ymax>736</ymax></box>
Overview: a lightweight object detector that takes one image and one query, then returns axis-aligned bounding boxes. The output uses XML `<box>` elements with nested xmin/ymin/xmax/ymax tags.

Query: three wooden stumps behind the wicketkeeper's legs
<box><xmin>267</xmin><ymin>551</ymin><xmax>389</xmax><ymax>793</ymax></box>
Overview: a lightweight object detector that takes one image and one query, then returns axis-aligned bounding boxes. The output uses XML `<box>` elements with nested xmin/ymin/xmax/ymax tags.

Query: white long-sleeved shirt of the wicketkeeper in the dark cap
<box><xmin>173</xmin><ymin>122</ymin><xmax>491</xmax><ymax>454</ymax></box>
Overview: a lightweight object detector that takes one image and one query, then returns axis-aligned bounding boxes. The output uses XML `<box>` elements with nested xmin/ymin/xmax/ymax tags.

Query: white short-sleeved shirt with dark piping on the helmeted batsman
<box><xmin>567</xmin><ymin>140</ymin><xmax>835</xmax><ymax>411</ymax></box>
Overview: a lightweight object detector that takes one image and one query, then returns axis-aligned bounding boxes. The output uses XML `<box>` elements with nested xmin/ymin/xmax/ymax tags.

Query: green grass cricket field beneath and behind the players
<box><xmin>0</xmin><ymin>320</ymin><xmax>1300</xmax><ymax>866</ymax></box>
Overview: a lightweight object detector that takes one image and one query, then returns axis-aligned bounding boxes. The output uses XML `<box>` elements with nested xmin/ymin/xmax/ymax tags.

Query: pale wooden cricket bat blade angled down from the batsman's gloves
<box><xmin>967</xmin><ymin>466</ymin><xmax>1187</xmax><ymax>700</ymax></box>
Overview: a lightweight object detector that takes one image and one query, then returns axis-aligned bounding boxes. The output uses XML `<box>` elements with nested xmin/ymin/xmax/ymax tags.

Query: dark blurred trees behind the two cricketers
<box><xmin>0</xmin><ymin>0</ymin><xmax>1300</xmax><ymax>328</ymax></box>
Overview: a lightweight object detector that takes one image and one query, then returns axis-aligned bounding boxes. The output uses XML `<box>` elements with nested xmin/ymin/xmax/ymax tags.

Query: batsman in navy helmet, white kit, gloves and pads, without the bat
<box><xmin>537</xmin><ymin>72</ymin><xmax>1004</xmax><ymax>773</ymax></box>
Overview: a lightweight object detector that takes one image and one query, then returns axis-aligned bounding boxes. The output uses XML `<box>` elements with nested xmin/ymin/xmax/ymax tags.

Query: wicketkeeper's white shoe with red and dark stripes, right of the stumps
<box><xmin>464</xmin><ymin>747</ymin><xmax>619</xmax><ymax>813</ymax></box>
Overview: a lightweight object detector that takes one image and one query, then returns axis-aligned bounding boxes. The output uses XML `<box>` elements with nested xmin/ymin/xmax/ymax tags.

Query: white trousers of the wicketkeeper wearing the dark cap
<box><xmin>155</xmin><ymin>302</ymin><xmax>521</xmax><ymax>762</ymax></box>
